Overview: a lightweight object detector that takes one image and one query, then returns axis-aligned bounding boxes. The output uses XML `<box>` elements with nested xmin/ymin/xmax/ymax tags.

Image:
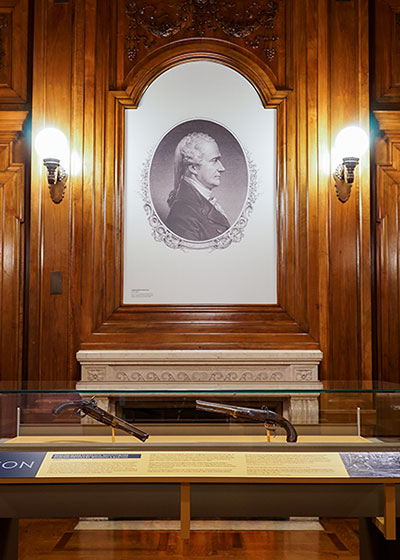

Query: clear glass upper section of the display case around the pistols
<box><xmin>0</xmin><ymin>387</ymin><xmax>400</xmax><ymax>451</ymax></box>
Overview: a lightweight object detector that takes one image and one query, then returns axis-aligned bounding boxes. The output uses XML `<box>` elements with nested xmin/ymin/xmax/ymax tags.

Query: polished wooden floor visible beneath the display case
<box><xmin>19</xmin><ymin>519</ymin><xmax>359</xmax><ymax>560</ymax></box>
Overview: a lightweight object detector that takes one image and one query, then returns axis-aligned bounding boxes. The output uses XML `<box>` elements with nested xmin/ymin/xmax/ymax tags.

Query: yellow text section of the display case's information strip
<box><xmin>37</xmin><ymin>451</ymin><xmax>349</xmax><ymax>478</ymax></box>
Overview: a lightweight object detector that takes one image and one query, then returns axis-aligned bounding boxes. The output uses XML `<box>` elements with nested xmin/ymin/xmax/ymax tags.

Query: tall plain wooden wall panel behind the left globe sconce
<box><xmin>28</xmin><ymin>1</ymin><xmax>74</xmax><ymax>388</ymax></box>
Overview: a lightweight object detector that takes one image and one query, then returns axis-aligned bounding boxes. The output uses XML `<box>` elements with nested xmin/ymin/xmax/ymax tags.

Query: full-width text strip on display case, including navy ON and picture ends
<box><xmin>0</xmin><ymin>451</ymin><xmax>400</xmax><ymax>480</ymax></box>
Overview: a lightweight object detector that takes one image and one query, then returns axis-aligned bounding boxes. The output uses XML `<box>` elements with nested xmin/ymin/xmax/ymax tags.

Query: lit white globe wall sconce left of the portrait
<box><xmin>35</xmin><ymin>128</ymin><xmax>69</xmax><ymax>204</ymax></box>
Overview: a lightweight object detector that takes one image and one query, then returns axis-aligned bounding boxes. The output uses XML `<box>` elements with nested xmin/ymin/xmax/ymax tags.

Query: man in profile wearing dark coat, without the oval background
<box><xmin>166</xmin><ymin>132</ymin><xmax>230</xmax><ymax>241</ymax></box>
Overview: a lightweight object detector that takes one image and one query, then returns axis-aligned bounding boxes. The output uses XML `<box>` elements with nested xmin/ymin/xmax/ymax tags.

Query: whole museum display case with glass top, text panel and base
<box><xmin>0</xmin><ymin>387</ymin><xmax>400</xmax><ymax>560</ymax></box>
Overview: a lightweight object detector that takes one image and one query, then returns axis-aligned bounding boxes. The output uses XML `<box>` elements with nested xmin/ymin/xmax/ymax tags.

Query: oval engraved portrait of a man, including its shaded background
<box><xmin>149</xmin><ymin>119</ymin><xmax>249</xmax><ymax>248</ymax></box>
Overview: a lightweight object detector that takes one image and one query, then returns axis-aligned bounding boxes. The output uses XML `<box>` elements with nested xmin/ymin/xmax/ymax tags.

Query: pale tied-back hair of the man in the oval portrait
<box><xmin>168</xmin><ymin>132</ymin><xmax>215</xmax><ymax>207</ymax></box>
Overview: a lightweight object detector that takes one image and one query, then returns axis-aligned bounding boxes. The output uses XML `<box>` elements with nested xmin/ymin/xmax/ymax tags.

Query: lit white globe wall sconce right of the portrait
<box><xmin>333</xmin><ymin>126</ymin><xmax>369</xmax><ymax>202</ymax></box>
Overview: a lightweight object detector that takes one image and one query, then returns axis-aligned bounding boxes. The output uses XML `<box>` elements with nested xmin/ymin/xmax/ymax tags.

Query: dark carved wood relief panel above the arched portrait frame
<box><xmin>120</xmin><ymin>0</ymin><xmax>286</xmax><ymax>87</ymax></box>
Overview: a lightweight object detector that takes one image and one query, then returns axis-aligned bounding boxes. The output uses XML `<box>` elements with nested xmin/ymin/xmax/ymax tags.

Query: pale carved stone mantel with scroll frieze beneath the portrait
<box><xmin>78</xmin><ymin>350</ymin><xmax>322</xmax><ymax>388</ymax></box>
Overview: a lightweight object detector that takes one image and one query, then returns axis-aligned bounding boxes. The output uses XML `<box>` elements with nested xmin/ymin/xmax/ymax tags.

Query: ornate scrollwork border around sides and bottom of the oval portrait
<box><xmin>140</xmin><ymin>140</ymin><xmax>258</xmax><ymax>251</ymax></box>
